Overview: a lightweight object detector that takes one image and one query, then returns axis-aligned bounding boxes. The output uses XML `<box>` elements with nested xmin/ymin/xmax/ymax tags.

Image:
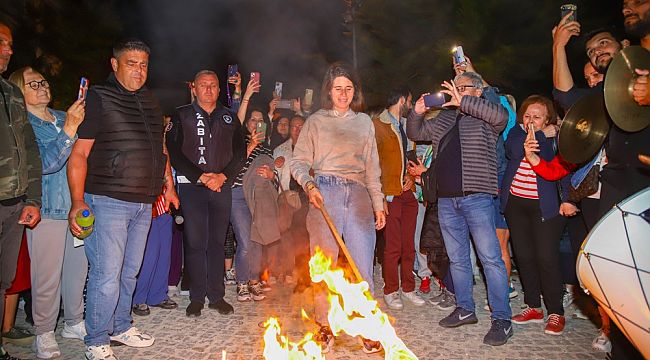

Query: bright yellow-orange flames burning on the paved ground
<box><xmin>264</xmin><ymin>249</ymin><xmax>417</xmax><ymax>360</ymax></box>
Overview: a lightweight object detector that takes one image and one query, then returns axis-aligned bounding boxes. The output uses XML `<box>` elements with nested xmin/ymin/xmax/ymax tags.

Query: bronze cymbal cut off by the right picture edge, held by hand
<box><xmin>604</xmin><ymin>46</ymin><xmax>650</xmax><ymax>132</ymax></box>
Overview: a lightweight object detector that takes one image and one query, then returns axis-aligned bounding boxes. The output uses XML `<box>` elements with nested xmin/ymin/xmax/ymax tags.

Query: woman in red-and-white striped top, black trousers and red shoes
<box><xmin>500</xmin><ymin>95</ymin><xmax>577</xmax><ymax>335</ymax></box>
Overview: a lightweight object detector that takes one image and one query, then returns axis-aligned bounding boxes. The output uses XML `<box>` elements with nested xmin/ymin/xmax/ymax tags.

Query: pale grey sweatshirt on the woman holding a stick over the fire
<box><xmin>291</xmin><ymin>109</ymin><xmax>384</xmax><ymax>211</ymax></box>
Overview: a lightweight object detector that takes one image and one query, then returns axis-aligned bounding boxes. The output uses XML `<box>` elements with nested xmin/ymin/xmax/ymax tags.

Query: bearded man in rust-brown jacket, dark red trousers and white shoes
<box><xmin>372</xmin><ymin>87</ymin><xmax>424</xmax><ymax>310</ymax></box>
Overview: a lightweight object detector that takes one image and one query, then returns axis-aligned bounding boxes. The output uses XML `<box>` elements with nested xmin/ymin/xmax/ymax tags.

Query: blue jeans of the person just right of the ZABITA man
<box><xmin>230</xmin><ymin>186</ymin><xmax>262</xmax><ymax>283</ymax></box>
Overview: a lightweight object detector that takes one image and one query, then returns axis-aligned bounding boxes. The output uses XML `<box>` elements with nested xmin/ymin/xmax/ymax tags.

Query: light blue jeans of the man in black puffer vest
<box><xmin>84</xmin><ymin>193</ymin><xmax>151</xmax><ymax>346</ymax></box>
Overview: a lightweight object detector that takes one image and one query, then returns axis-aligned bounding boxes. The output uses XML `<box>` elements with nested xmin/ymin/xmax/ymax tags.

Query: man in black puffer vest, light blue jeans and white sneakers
<box><xmin>68</xmin><ymin>39</ymin><xmax>178</xmax><ymax>360</ymax></box>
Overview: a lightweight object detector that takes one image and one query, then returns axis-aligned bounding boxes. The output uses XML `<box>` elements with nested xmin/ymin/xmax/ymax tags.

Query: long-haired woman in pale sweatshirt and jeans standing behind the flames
<box><xmin>291</xmin><ymin>63</ymin><xmax>384</xmax><ymax>353</ymax></box>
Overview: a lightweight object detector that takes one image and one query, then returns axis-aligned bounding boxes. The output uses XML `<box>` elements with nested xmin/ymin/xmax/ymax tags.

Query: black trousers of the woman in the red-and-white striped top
<box><xmin>505</xmin><ymin>195</ymin><xmax>566</xmax><ymax>315</ymax></box>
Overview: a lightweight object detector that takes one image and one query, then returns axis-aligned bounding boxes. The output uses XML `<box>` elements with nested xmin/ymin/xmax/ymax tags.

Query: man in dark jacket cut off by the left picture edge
<box><xmin>0</xmin><ymin>20</ymin><xmax>43</xmax><ymax>358</ymax></box>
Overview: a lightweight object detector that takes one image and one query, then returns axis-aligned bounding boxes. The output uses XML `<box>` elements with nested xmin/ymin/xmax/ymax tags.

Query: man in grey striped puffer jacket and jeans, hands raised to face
<box><xmin>406</xmin><ymin>72</ymin><xmax>513</xmax><ymax>346</ymax></box>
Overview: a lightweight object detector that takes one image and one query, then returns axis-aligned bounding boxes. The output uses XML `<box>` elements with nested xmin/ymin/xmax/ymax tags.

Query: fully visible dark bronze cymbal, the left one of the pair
<box><xmin>558</xmin><ymin>92</ymin><xmax>610</xmax><ymax>164</ymax></box>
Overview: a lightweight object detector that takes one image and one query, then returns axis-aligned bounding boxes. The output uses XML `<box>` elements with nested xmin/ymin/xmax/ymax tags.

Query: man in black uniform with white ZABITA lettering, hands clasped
<box><xmin>167</xmin><ymin>70</ymin><xmax>246</xmax><ymax>317</ymax></box>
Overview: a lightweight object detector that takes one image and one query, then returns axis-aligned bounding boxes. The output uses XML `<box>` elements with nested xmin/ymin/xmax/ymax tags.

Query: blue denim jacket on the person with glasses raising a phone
<box><xmin>27</xmin><ymin>108</ymin><xmax>77</xmax><ymax>220</ymax></box>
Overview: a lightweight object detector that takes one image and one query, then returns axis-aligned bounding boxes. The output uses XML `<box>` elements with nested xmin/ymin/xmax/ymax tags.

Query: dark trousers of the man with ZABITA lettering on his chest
<box><xmin>178</xmin><ymin>184</ymin><xmax>232</xmax><ymax>303</ymax></box>
